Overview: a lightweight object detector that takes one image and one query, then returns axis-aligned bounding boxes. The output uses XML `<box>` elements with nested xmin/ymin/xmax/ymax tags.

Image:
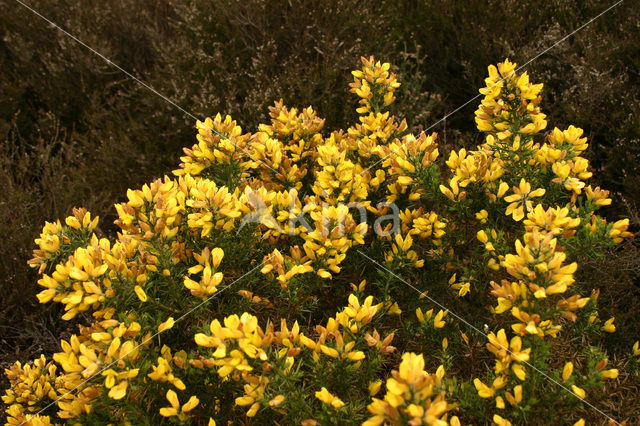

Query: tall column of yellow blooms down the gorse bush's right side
<box><xmin>452</xmin><ymin>61</ymin><xmax>632</xmax><ymax>424</ymax></box>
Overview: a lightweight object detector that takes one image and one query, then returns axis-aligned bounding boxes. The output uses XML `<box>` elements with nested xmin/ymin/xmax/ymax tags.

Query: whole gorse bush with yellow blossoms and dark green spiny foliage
<box><xmin>3</xmin><ymin>58</ymin><xmax>640</xmax><ymax>425</ymax></box>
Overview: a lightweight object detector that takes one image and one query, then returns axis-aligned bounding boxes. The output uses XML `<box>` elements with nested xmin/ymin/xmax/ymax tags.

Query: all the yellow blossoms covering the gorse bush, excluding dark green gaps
<box><xmin>10</xmin><ymin>58</ymin><xmax>640</xmax><ymax>426</ymax></box>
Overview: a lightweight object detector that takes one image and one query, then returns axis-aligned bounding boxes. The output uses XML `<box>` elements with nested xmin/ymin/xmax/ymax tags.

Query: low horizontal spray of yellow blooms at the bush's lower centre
<box><xmin>194</xmin><ymin>294</ymin><xmax>395</xmax><ymax>417</ymax></box>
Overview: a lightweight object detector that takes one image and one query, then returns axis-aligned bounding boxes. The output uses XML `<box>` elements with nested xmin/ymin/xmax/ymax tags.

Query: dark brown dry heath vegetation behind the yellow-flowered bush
<box><xmin>0</xmin><ymin>0</ymin><xmax>640</xmax><ymax>420</ymax></box>
